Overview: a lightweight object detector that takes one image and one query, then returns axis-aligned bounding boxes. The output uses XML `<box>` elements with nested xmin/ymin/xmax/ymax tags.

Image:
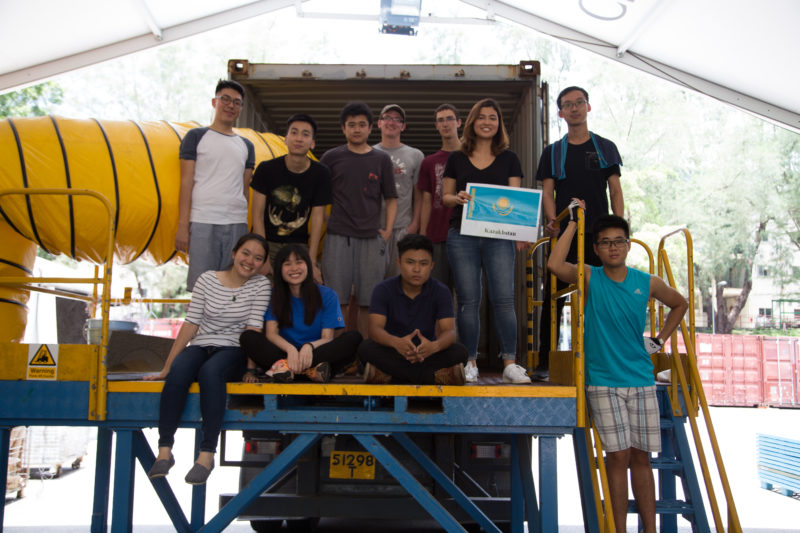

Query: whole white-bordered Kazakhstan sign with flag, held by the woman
<box><xmin>461</xmin><ymin>183</ymin><xmax>542</xmax><ymax>242</ymax></box>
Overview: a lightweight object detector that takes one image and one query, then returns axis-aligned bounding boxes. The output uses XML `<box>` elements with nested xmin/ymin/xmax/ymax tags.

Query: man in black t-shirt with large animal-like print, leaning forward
<box><xmin>250</xmin><ymin>114</ymin><xmax>331</xmax><ymax>283</ymax></box>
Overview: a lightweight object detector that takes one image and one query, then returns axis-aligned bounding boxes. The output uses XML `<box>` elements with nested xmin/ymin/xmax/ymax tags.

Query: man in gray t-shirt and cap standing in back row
<box><xmin>373</xmin><ymin>104</ymin><xmax>424</xmax><ymax>278</ymax></box>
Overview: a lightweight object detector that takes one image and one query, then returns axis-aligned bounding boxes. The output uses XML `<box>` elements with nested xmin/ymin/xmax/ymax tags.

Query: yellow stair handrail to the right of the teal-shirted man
<box><xmin>658</xmin><ymin>228</ymin><xmax>742</xmax><ymax>533</ymax></box>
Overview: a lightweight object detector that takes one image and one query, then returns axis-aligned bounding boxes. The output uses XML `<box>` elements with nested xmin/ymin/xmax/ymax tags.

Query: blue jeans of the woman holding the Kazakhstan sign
<box><xmin>447</xmin><ymin>228</ymin><xmax>517</xmax><ymax>361</ymax></box>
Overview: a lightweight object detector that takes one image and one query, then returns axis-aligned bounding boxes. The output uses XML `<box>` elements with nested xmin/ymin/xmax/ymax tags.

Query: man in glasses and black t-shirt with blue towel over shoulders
<box><xmin>533</xmin><ymin>86</ymin><xmax>625</xmax><ymax>380</ymax></box>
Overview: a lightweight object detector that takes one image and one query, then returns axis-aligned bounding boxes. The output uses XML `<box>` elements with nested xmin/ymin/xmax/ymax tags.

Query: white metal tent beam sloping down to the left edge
<box><xmin>0</xmin><ymin>0</ymin><xmax>308</xmax><ymax>91</ymax></box>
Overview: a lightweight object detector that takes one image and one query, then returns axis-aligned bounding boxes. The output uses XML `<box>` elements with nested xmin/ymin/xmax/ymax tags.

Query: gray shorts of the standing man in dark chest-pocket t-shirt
<box><xmin>322</xmin><ymin>233</ymin><xmax>386</xmax><ymax>307</ymax></box>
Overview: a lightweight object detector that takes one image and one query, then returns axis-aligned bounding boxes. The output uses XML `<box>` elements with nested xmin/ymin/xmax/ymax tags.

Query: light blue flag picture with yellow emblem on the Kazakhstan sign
<box><xmin>467</xmin><ymin>185</ymin><xmax>539</xmax><ymax>226</ymax></box>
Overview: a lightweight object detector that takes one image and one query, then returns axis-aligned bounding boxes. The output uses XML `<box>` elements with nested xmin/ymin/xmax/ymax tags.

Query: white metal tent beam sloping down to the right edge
<box><xmin>461</xmin><ymin>0</ymin><xmax>800</xmax><ymax>133</ymax></box>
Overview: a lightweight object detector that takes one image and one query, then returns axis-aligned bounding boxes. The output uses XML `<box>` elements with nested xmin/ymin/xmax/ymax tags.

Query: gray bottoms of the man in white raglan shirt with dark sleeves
<box><xmin>186</xmin><ymin>222</ymin><xmax>247</xmax><ymax>291</ymax></box>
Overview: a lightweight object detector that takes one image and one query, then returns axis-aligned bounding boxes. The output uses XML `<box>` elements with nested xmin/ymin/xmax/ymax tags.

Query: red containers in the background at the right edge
<box><xmin>679</xmin><ymin>333</ymin><xmax>800</xmax><ymax>407</ymax></box>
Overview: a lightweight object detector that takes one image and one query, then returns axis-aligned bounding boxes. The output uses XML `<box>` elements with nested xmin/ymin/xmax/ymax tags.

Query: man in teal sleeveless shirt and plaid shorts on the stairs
<box><xmin>547</xmin><ymin>204</ymin><xmax>689</xmax><ymax>533</ymax></box>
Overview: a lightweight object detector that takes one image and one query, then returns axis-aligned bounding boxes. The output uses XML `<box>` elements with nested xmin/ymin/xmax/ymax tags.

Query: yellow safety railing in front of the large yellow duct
<box><xmin>0</xmin><ymin>188</ymin><xmax>114</xmax><ymax>420</ymax></box>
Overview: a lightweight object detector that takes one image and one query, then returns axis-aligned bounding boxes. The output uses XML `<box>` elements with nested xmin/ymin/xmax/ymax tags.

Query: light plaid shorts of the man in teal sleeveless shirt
<box><xmin>586</xmin><ymin>385</ymin><xmax>661</xmax><ymax>452</ymax></box>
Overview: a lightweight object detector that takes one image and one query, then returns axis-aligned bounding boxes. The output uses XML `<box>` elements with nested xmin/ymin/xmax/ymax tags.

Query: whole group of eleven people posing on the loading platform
<box><xmin>144</xmin><ymin>81</ymin><xmax>686</xmax><ymax>531</ymax></box>
